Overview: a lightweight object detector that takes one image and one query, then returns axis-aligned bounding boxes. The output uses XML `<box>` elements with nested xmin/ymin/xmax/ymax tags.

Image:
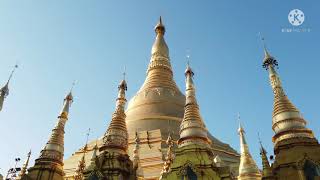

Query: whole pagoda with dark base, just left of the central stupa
<box><xmin>84</xmin><ymin>80</ymin><xmax>136</xmax><ymax>180</ymax></box>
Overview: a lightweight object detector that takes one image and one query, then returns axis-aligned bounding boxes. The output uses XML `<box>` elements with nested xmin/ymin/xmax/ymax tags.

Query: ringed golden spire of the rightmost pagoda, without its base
<box><xmin>262</xmin><ymin>39</ymin><xmax>314</xmax><ymax>144</ymax></box>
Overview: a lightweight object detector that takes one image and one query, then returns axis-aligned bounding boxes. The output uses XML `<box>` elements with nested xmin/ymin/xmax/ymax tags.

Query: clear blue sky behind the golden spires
<box><xmin>0</xmin><ymin>0</ymin><xmax>320</xmax><ymax>174</ymax></box>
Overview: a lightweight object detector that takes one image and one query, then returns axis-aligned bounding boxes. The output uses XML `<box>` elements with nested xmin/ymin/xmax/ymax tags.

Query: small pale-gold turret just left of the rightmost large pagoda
<box><xmin>238</xmin><ymin>124</ymin><xmax>261</xmax><ymax>180</ymax></box>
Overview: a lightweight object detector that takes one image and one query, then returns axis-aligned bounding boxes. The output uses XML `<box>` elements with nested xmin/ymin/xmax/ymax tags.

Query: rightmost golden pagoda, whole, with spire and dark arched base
<box><xmin>263</xmin><ymin>47</ymin><xmax>320</xmax><ymax>180</ymax></box>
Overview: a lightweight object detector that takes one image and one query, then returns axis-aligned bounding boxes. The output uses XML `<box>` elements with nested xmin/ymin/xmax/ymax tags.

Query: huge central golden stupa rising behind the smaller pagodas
<box><xmin>64</xmin><ymin>18</ymin><xmax>240</xmax><ymax>179</ymax></box>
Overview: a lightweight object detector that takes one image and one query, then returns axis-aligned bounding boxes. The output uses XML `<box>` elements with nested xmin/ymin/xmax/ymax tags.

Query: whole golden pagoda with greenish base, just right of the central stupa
<box><xmin>160</xmin><ymin>65</ymin><xmax>233</xmax><ymax>180</ymax></box>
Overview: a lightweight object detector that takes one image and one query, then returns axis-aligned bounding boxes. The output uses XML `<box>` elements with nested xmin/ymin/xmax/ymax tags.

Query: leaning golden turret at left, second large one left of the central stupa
<box><xmin>28</xmin><ymin>88</ymin><xmax>73</xmax><ymax>180</ymax></box>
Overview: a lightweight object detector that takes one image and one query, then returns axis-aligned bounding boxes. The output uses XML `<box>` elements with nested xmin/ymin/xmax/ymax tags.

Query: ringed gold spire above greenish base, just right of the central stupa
<box><xmin>178</xmin><ymin>64</ymin><xmax>211</xmax><ymax>146</ymax></box>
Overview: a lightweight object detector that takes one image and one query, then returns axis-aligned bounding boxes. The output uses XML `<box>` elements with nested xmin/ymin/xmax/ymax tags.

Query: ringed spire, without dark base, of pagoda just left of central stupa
<box><xmin>100</xmin><ymin>76</ymin><xmax>128</xmax><ymax>154</ymax></box>
